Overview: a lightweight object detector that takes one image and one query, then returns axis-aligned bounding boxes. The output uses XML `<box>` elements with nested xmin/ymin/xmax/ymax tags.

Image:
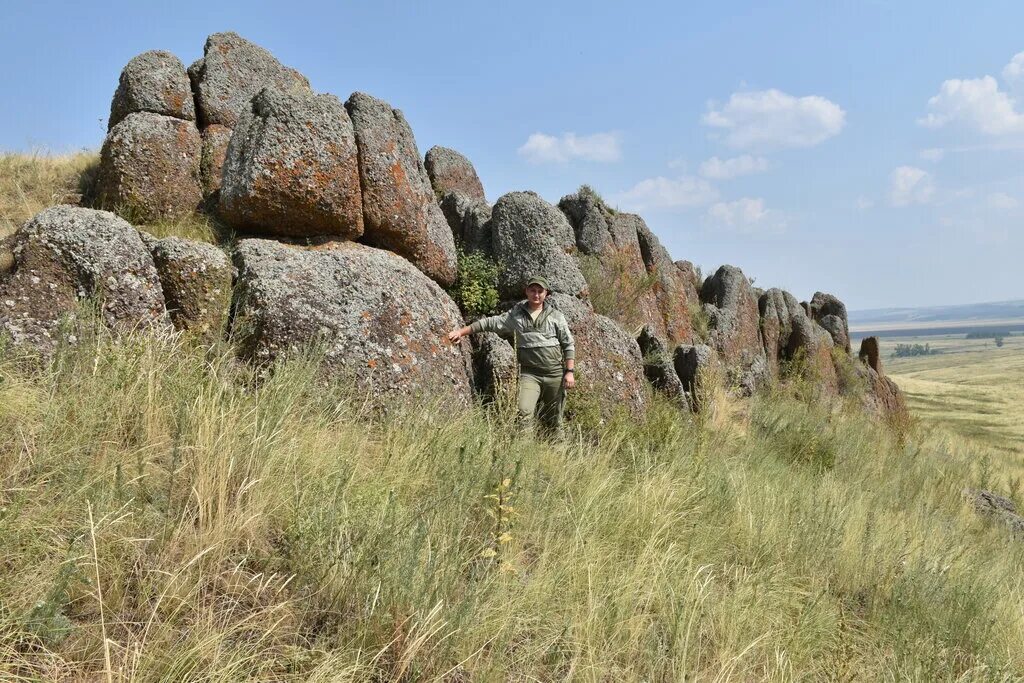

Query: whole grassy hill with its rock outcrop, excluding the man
<box><xmin>0</xmin><ymin>34</ymin><xmax>1024</xmax><ymax>681</ymax></box>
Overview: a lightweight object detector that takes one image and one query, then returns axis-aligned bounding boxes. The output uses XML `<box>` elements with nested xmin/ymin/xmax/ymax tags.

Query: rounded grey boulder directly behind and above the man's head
<box><xmin>490</xmin><ymin>191</ymin><xmax>589</xmax><ymax>299</ymax></box>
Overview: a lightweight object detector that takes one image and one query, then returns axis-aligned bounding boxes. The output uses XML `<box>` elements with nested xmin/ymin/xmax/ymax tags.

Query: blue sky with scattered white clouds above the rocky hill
<box><xmin>0</xmin><ymin>0</ymin><xmax>1024</xmax><ymax>309</ymax></box>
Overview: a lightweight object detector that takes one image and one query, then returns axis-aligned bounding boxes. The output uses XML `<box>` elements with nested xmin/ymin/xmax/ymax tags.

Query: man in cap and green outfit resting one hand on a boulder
<box><xmin>449</xmin><ymin>276</ymin><xmax>575</xmax><ymax>436</ymax></box>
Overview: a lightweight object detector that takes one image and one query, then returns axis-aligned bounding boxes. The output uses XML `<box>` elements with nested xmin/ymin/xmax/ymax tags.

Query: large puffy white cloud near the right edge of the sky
<box><xmin>918</xmin><ymin>76</ymin><xmax>1024</xmax><ymax>135</ymax></box>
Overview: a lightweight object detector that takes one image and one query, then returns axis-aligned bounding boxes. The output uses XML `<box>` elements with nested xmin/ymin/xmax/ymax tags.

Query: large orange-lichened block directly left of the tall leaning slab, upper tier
<box><xmin>220</xmin><ymin>88</ymin><xmax>362</xmax><ymax>240</ymax></box>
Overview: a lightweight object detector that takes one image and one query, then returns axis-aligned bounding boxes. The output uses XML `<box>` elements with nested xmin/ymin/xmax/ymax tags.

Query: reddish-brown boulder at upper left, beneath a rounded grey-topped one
<box><xmin>96</xmin><ymin>112</ymin><xmax>203</xmax><ymax>221</ymax></box>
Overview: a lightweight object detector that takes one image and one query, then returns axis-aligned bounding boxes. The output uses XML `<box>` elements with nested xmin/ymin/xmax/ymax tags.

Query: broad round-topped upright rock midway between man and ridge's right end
<box><xmin>700</xmin><ymin>265</ymin><xmax>770</xmax><ymax>393</ymax></box>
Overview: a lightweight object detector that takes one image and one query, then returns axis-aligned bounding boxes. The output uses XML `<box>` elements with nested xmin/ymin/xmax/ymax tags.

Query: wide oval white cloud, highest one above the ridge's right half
<box><xmin>701</xmin><ymin>89</ymin><xmax>846</xmax><ymax>150</ymax></box>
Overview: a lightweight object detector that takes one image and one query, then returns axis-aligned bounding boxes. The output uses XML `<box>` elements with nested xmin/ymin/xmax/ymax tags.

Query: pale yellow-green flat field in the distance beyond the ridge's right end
<box><xmin>868</xmin><ymin>331</ymin><xmax>1024</xmax><ymax>456</ymax></box>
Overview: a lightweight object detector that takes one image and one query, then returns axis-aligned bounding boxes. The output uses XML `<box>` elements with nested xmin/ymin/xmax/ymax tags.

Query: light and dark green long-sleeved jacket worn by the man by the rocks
<box><xmin>469</xmin><ymin>301</ymin><xmax>575</xmax><ymax>375</ymax></box>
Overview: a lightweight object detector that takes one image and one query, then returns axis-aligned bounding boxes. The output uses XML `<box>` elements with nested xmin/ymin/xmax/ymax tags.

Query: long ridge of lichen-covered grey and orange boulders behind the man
<box><xmin>0</xmin><ymin>33</ymin><xmax>906</xmax><ymax>423</ymax></box>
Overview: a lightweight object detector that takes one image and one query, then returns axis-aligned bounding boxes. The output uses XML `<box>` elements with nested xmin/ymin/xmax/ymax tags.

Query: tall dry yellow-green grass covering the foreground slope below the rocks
<box><xmin>0</xmin><ymin>327</ymin><xmax>1024</xmax><ymax>681</ymax></box>
